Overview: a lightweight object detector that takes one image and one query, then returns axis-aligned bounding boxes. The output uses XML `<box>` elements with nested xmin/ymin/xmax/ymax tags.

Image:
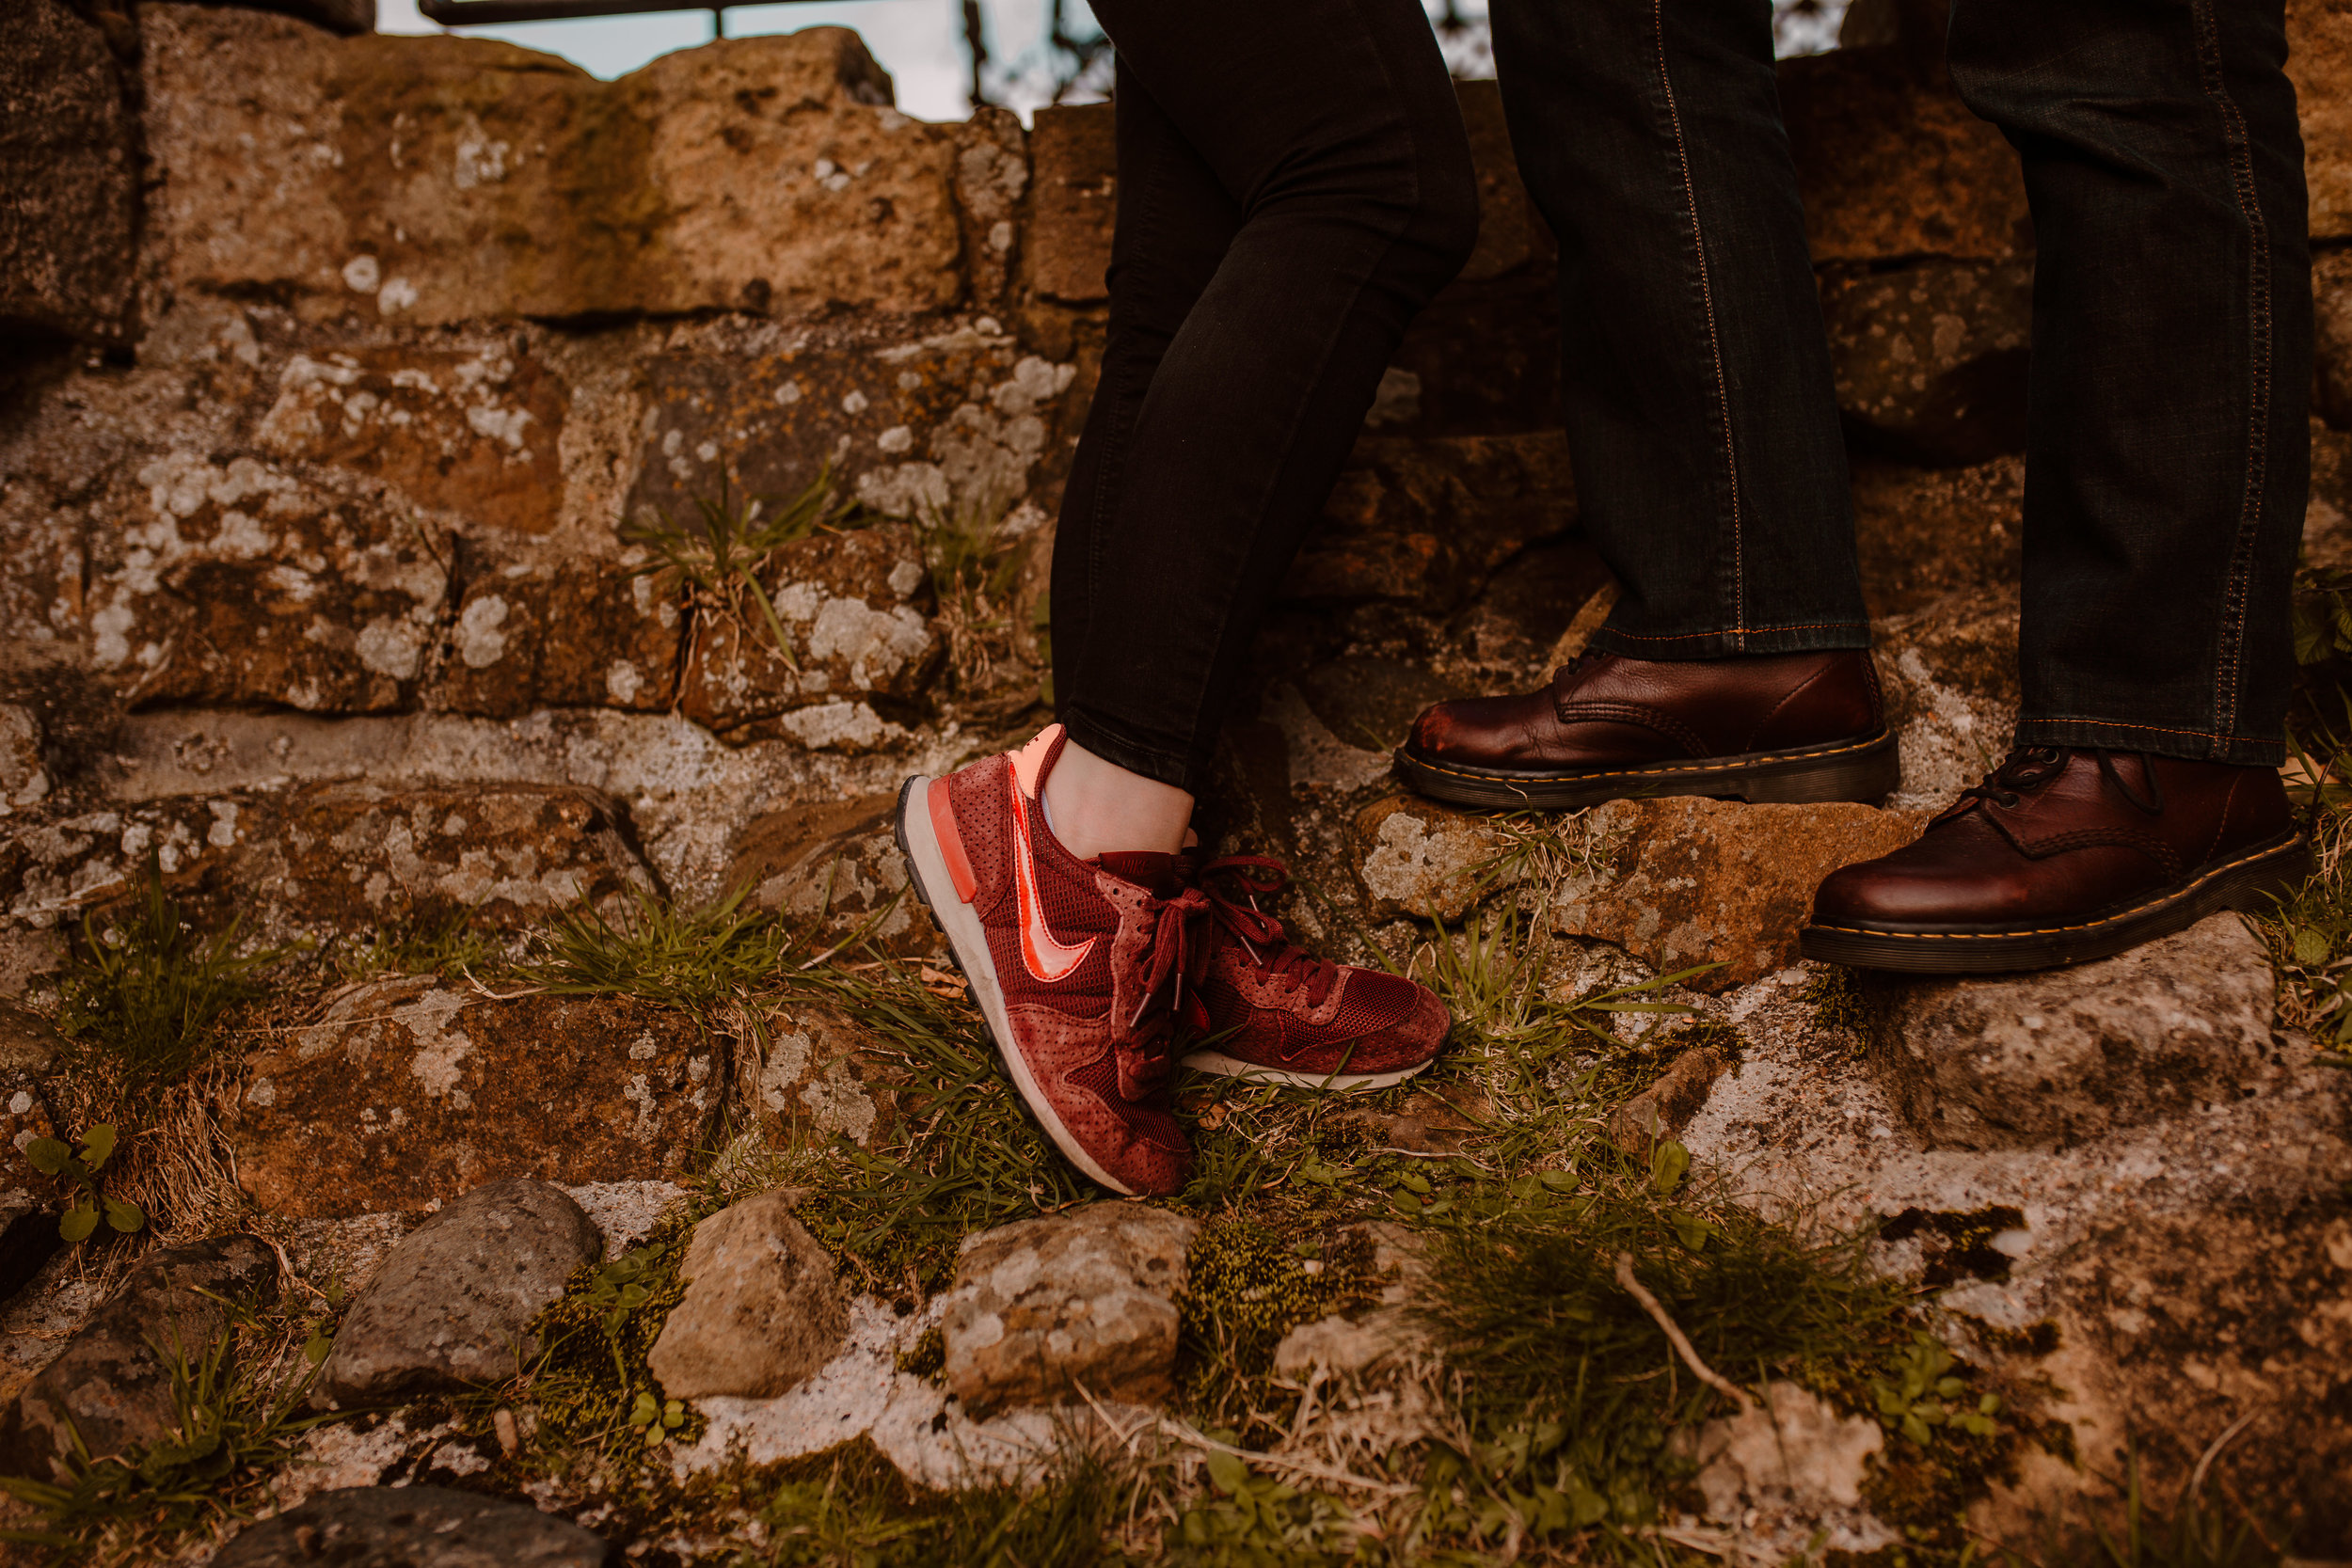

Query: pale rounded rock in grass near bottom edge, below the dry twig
<box><xmin>1689</xmin><ymin>1383</ymin><xmax>1886</xmax><ymax>1521</ymax></box>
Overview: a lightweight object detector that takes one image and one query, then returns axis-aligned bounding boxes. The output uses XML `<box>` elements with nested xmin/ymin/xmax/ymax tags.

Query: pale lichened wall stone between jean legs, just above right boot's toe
<box><xmin>1877</xmin><ymin>588</ymin><xmax>2018</xmax><ymax>809</ymax></box>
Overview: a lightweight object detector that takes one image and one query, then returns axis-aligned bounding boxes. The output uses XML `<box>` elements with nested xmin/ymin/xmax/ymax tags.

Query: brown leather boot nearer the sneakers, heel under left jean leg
<box><xmin>1397</xmin><ymin>649</ymin><xmax>1903</xmax><ymax>806</ymax></box>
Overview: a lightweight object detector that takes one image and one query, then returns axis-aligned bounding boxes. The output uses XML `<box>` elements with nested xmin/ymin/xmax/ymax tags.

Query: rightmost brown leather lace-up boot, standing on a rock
<box><xmin>1802</xmin><ymin>745</ymin><xmax>2312</xmax><ymax>974</ymax></box>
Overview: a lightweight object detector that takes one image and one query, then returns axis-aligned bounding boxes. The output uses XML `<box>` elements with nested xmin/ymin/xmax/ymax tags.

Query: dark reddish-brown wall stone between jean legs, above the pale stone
<box><xmin>1853</xmin><ymin>458</ymin><xmax>2026</xmax><ymax>615</ymax></box>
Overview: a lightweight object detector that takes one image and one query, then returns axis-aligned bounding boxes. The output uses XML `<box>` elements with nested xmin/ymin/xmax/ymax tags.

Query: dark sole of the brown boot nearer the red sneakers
<box><xmin>1395</xmin><ymin>729</ymin><xmax>1903</xmax><ymax>809</ymax></box>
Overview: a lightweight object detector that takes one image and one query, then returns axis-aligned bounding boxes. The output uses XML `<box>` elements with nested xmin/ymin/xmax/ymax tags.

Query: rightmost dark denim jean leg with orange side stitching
<box><xmin>1952</xmin><ymin>0</ymin><xmax>2312</xmax><ymax>767</ymax></box>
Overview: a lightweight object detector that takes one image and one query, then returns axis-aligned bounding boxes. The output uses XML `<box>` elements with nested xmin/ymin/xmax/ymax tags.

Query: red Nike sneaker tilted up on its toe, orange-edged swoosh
<box><xmin>898</xmin><ymin>724</ymin><xmax>1209</xmax><ymax>1195</ymax></box>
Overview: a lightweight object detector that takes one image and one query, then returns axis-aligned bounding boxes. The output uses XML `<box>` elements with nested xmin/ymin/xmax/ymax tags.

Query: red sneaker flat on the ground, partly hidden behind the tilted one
<box><xmin>1181</xmin><ymin>856</ymin><xmax>1454</xmax><ymax>1088</ymax></box>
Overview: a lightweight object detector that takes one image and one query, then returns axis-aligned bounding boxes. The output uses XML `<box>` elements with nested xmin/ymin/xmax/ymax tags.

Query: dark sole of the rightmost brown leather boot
<box><xmin>1797</xmin><ymin>832</ymin><xmax>2312</xmax><ymax>975</ymax></box>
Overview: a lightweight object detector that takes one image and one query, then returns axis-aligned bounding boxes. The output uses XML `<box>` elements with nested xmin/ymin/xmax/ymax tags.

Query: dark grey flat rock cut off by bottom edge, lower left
<box><xmin>212</xmin><ymin>1486</ymin><xmax>624</xmax><ymax>1568</ymax></box>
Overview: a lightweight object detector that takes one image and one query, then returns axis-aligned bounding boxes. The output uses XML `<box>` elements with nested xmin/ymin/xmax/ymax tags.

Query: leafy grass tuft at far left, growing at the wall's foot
<box><xmin>59</xmin><ymin>853</ymin><xmax>285</xmax><ymax>1088</ymax></box>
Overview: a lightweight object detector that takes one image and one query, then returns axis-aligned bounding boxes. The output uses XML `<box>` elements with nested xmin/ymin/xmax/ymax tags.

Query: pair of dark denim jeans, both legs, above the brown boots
<box><xmin>1494</xmin><ymin>0</ymin><xmax>2312</xmax><ymax>764</ymax></box>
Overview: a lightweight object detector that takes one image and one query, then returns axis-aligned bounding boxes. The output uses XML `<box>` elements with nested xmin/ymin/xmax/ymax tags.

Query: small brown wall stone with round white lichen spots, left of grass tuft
<box><xmin>428</xmin><ymin>560</ymin><xmax>685</xmax><ymax>720</ymax></box>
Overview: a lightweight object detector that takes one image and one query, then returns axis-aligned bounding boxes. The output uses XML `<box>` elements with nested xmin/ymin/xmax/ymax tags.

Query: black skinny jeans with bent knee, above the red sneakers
<box><xmin>1052</xmin><ymin>0</ymin><xmax>1477</xmax><ymax>792</ymax></box>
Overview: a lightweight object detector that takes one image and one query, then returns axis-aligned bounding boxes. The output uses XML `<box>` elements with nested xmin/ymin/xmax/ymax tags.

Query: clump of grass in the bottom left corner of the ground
<box><xmin>0</xmin><ymin>1305</ymin><xmax>339</xmax><ymax>1566</ymax></box>
